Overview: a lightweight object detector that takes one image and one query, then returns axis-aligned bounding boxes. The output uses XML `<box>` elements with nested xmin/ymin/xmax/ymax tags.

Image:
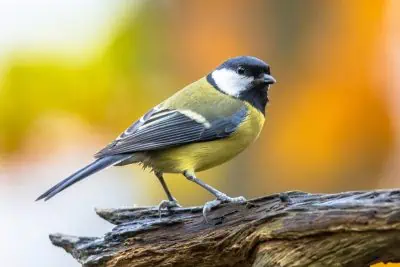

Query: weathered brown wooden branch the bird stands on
<box><xmin>50</xmin><ymin>190</ymin><xmax>400</xmax><ymax>267</ymax></box>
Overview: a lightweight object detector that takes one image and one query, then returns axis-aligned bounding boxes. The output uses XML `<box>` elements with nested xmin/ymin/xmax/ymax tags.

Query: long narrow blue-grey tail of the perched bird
<box><xmin>36</xmin><ymin>155</ymin><xmax>132</xmax><ymax>201</ymax></box>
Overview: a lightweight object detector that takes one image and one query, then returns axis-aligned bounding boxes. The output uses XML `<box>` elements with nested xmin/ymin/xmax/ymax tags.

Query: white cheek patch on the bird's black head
<box><xmin>211</xmin><ymin>69</ymin><xmax>254</xmax><ymax>97</ymax></box>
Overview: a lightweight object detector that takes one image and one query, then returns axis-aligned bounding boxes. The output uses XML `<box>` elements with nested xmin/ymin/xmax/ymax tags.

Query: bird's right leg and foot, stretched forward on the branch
<box><xmin>183</xmin><ymin>171</ymin><xmax>247</xmax><ymax>223</ymax></box>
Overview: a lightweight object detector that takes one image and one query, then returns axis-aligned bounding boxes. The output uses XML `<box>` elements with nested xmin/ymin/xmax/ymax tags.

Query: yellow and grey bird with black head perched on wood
<box><xmin>36</xmin><ymin>56</ymin><xmax>276</xmax><ymax>222</ymax></box>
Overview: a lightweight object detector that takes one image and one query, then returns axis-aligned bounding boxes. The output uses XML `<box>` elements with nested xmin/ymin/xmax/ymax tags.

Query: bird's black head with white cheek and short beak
<box><xmin>207</xmin><ymin>56</ymin><xmax>276</xmax><ymax>112</ymax></box>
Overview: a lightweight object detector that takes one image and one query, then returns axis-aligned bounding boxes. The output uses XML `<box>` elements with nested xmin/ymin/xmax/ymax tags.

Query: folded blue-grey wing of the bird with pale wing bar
<box><xmin>95</xmin><ymin>106</ymin><xmax>247</xmax><ymax>158</ymax></box>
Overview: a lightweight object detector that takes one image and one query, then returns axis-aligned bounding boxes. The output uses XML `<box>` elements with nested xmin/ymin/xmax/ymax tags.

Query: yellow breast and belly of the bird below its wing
<box><xmin>147</xmin><ymin>103</ymin><xmax>265</xmax><ymax>173</ymax></box>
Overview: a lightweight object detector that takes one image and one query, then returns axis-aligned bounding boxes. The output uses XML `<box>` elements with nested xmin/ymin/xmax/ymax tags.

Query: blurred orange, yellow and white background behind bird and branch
<box><xmin>0</xmin><ymin>0</ymin><xmax>400</xmax><ymax>267</ymax></box>
